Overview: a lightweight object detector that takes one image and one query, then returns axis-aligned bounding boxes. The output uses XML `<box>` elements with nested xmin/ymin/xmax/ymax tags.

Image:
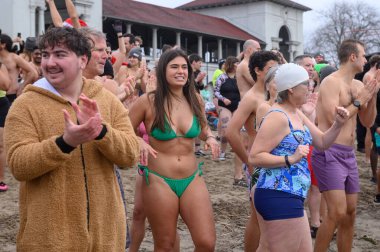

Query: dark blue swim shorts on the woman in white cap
<box><xmin>254</xmin><ymin>188</ymin><xmax>304</xmax><ymax>221</ymax></box>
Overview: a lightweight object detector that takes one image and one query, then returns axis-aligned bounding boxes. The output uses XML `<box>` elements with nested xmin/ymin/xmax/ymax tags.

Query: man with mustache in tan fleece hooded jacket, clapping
<box><xmin>5</xmin><ymin>28</ymin><xmax>139</xmax><ymax>251</ymax></box>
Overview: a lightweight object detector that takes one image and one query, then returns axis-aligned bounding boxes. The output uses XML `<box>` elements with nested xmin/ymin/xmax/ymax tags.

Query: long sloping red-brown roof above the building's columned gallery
<box><xmin>103</xmin><ymin>0</ymin><xmax>266</xmax><ymax>45</ymax></box>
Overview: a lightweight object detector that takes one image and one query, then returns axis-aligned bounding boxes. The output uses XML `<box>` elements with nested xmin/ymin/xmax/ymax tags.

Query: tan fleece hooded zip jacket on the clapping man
<box><xmin>4</xmin><ymin>79</ymin><xmax>139</xmax><ymax>252</ymax></box>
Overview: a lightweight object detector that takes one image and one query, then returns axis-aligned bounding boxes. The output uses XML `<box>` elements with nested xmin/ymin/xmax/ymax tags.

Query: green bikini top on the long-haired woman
<box><xmin>151</xmin><ymin>115</ymin><xmax>201</xmax><ymax>141</ymax></box>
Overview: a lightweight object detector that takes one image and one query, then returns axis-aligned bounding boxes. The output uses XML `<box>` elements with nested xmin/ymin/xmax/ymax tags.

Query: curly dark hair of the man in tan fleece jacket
<box><xmin>38</xmin><ymin>27</ymin><xmax>93</xmax><ymax>61</ymax></box>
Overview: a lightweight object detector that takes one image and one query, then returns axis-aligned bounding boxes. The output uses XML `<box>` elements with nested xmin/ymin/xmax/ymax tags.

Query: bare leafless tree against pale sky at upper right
<box><xmin>307</xmin><ymin>1</ymin><xmax>380</xmax><ymax>64</ymax></box>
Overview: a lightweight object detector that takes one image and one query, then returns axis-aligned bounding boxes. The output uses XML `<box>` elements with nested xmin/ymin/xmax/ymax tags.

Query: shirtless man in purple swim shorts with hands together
<box><xmin>312</xmin><ymin>40</ymin><xmax>380</xmax><ymax>252</ymax></box>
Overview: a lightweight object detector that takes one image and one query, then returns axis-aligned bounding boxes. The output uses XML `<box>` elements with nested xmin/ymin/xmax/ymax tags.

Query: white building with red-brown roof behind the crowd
<box><xmin>0</xmin><ymin>0</ymin><xmax>311</xmax><ymax>62</ymax></box>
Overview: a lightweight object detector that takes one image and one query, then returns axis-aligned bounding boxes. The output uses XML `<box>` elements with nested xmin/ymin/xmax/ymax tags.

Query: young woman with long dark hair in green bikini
<box><xmin>129</xmin><ymin>49</ymin><xmax>219</xmax><ymax>251</ymax></box>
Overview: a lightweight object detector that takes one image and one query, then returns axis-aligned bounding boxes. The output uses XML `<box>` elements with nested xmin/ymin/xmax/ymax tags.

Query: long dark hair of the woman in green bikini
<box><xmin>149</xmin><ymin>49</ymin><xmax>206</xmax><ymax>132</ymax></box>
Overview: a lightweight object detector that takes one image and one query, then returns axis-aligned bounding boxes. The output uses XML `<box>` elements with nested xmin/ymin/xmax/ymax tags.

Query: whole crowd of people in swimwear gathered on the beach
<box><xmin>0</xmin><ymin>0</ymin><xmax>380</xmax><ymax>252</ymax></box>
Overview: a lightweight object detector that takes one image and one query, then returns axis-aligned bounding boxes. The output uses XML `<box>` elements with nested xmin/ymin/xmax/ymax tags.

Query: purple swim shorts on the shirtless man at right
<box><xmin>311</xmin><ymin>144</ymin><xmax>360</xmax><ymax>194</ymax></box>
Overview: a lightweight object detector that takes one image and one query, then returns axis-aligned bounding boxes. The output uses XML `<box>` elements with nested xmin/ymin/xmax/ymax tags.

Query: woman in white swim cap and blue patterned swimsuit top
<box><xmin>249</xmin><ymin>63</ymin><xmax>348</xmax><ymax>252</ymax></box>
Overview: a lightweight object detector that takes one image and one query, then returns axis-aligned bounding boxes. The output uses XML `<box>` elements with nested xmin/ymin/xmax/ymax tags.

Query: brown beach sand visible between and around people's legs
<box><xmin>0</xmin><ymin>149</ymin><xmax>380</xmax><ymax>252</ymax></box>
